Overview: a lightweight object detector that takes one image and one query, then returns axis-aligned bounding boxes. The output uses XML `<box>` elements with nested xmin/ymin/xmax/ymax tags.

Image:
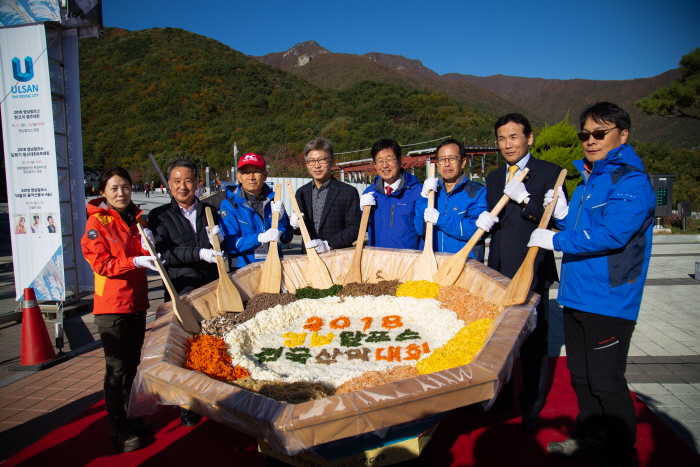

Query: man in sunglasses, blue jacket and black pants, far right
<box><xmin>528</xmin><ymin>102</ymin><xmax>655</xmax><ymax>466</ymax></box>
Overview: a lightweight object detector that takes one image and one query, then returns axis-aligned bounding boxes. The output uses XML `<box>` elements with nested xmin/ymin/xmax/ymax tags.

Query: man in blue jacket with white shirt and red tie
<box><xmin>360</xmin><ymin>139</ymin><xmax>423</xmax><ymax>250</ymax></box>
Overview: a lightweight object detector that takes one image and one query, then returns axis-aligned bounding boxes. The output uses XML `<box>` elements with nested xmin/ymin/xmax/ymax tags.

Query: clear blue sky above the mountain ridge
<box><xmin>103</xmin><ymin>0</ymin><xmax>700</xmax><ymax>79</ymax></box>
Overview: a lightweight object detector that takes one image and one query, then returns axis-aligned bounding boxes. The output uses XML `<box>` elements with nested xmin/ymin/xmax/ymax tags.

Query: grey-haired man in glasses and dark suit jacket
<box><xmin>290</xmin><ymin>138</ymin><xmax>360</xmax><ymax>253</ymax></box>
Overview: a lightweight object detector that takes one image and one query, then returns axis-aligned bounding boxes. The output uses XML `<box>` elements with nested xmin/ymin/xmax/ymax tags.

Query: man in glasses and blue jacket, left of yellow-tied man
<box><xmin>414</xmin><ymin>138</ymin><xmax>486</xmax><ymax>263</ymax></box>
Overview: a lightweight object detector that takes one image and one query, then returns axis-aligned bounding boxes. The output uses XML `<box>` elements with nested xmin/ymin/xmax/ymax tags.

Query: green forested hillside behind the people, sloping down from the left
<box><xmin>80</xmin><ymin>28</ymin><xmax>494</xmax><ymax>175</ymax></box>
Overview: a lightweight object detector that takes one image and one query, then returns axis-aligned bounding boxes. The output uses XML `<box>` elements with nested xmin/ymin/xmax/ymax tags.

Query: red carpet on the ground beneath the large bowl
<box><xmin>3</xmin><ymin>358</ymin><xmax>700</xmax><ymax>467</ymax></box>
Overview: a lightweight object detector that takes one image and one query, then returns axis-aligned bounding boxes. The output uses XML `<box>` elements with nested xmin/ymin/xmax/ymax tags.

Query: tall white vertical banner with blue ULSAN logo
<box><xmin>0</xmin><ymin>24</ymin><xmax>65</xmax><ymax>301</ymax></box>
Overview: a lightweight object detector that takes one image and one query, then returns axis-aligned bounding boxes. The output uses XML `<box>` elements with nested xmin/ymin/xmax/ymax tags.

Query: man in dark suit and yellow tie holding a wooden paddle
<box><xmin>477</xmin><ymin>114</ymin><xmax>561</xmax><ymax>431</ymax></box>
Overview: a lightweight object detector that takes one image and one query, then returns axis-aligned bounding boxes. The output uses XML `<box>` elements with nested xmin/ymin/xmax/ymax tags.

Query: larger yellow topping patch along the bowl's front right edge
<box><xmin>416</xmin><ymin>318</ymin><xmax>494</xmax><ymax>375</ymax></box>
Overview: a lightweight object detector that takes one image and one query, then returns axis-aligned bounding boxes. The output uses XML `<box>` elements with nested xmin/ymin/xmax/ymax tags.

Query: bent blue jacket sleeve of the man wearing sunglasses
<box><xmin>553</xmin><ymin>172</ymin><xmax>655</xmax><ymax>255</ymax></box>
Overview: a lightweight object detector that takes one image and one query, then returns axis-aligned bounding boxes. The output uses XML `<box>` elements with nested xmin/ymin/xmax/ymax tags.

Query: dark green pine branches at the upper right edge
<box><xmin>635</xmin><ymin>48</ymin><xmax>700</xmax><ymax>120</ymax></box>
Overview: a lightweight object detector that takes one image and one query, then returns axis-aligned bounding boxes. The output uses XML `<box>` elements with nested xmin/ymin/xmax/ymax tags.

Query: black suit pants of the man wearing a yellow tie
<box><xmin>497</xmin><ymin>289</ymin><xmax>549</xmax><ymax>414</ymax></box>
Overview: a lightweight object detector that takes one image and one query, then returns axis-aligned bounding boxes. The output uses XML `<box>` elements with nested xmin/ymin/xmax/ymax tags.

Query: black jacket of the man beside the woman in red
<box><xmin>148</xmin><ymin>199</ymin><xmax>219</xmax><ymax>293</ymax></box>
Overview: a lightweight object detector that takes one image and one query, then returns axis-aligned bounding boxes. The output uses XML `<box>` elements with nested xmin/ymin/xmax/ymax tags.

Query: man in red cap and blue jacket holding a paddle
<box><xmin>220</xmin><ymin>153</ymin><xmax>293</xmax><ymax>269</ymax></box>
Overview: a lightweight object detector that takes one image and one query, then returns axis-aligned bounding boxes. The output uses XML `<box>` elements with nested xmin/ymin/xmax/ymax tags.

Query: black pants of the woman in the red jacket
<box><xmin>95</xmin><ymin>311</ymin><xmax>146</xmax><ymax>418</ymax></box>
